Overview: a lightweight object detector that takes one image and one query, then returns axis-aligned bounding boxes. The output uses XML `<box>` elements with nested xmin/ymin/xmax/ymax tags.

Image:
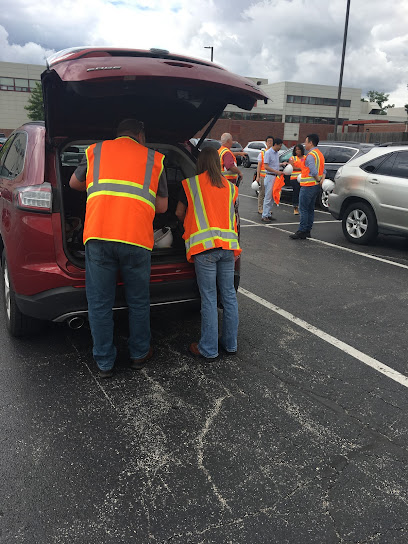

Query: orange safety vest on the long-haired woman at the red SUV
<box><xmin>182</xmin><ymin>172</ymin><xmax>242</xmax><ymax>262</ymax></box>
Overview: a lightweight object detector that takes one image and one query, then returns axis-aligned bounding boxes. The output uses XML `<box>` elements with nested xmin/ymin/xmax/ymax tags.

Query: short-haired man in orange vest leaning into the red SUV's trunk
<box><xmin>69</xmin><ymin>119</ymin><xmax>168</xmax><ymax>378</ymax></box>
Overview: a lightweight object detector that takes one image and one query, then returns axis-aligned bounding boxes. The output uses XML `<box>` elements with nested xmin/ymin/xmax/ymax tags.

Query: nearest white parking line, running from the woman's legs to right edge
<box><xmin>238</xmin><ymin>287</ymin><xmax>408</xmax><ymax>387</ymax></box>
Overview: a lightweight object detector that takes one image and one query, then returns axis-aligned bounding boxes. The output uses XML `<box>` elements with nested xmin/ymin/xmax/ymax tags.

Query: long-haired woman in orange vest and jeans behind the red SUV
<box><xmin>176</xmin><ymin>147</ymin><xmax>241</xmax><ymax>359</ymax></box>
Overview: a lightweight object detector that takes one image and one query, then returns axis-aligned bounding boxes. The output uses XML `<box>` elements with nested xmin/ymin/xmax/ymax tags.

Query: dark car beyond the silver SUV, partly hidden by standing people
<box><xmin>279</xmin><ymin>141</ymin><xmax>374</xmax><ymax>210</ymax></box>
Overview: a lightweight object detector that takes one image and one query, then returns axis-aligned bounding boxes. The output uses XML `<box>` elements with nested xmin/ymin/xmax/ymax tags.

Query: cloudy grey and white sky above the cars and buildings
<box><xmin>0</xmin><ymin>0</ymin><xmax>408</xmax><ymax>106</ymax></box>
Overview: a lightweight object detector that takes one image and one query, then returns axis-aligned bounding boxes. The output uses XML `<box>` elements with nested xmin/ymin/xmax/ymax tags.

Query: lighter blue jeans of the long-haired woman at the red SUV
<box><xmin>194</xmin><ymin>249</ymin><xmax>238</xmax><ymax>359</ymax></box>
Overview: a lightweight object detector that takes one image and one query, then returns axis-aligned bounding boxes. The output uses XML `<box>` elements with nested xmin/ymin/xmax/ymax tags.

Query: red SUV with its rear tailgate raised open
<box><xmin>0</xmin><ymin>48</ymin><xmax>267</xmax><ymax>336</ymax></box>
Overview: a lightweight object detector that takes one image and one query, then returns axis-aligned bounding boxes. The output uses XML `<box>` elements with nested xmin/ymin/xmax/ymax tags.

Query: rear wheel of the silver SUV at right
<box><xmin>342</xmin><ymin>202</ymin><xmax>378</xmax><ymax>244</ymax></box>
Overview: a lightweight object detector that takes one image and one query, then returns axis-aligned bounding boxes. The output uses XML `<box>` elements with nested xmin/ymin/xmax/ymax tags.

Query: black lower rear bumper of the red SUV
<box><xmin>15</xmin><ymin>278</ymin><xmax>200</xmax><ymax>322</ymax></box>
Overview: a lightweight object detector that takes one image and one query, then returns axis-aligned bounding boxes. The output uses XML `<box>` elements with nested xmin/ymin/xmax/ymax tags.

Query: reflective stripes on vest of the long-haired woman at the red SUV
<box><xmin>183</xmin><ymin>176</ymin><xmax>241</xmax><ymax>260</ymax></box>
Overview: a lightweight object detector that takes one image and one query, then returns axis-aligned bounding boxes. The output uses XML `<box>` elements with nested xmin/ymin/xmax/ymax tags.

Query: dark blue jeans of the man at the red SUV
<box><xmin>85</xmin><ymin>240</ymin><xmax>151</xmax><ymax>370</ymax></box>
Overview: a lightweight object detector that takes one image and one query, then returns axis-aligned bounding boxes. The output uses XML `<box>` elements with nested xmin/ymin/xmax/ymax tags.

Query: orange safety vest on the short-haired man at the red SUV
<box><xmin>84</xmin><ymin>136</ymin><xmax>164</xmax><ymax>250</ymax></box>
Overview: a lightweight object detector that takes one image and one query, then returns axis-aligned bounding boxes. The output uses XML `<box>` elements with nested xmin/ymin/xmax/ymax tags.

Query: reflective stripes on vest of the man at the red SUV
<box><xmin>87</xmin><ymin>142</ymin><xmax>156</xmax><ymax>210</ymax></box>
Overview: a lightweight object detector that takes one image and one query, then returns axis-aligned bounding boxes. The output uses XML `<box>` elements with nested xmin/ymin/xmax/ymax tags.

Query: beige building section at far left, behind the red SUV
<box><xmin>0</xmin><ymin>62</ymin><xmax>45</xmax><ymax>136</ymax></box>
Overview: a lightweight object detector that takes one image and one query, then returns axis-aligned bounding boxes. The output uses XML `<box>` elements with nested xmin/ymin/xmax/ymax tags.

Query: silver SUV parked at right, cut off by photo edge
<box><xmin>329</xmin><ymin>145</ymin><xmax>408</xmax><ymax>244</ymax></box>
